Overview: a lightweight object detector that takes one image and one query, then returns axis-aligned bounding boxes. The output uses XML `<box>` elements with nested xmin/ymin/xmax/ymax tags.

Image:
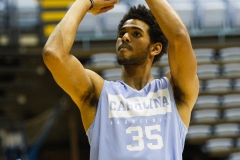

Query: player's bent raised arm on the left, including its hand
<box><xmin>43</xmin><ymin>0</ymin><xmax>117</xmax><ymax>129</ymax></box>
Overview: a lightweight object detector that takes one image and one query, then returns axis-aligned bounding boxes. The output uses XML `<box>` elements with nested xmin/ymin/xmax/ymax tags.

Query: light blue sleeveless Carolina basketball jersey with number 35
<box><xmin>87</xmin><ymin>77</ymin><xmax>187</xmax><ymax>160</ymax></box>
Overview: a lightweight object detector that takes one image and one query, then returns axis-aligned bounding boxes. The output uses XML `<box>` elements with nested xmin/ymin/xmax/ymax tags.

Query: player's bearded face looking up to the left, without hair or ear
<box><xmin>116</xmin><ymin>19</ymin><xmax>150</xmax><ymax>65</ymax></box>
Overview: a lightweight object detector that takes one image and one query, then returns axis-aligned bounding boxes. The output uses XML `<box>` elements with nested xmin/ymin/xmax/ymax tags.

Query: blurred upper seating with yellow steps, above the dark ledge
<box><xmin>0</xmin><ymin>0</ymin><xmax>240</xmax><ymax>44</ymax></box>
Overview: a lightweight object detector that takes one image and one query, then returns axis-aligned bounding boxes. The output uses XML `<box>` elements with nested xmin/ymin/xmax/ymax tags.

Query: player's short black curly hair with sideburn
<box><xmin>118</xmin><ymin>4</ymin><xmax>168</xmax><ymax>63</ymax></box>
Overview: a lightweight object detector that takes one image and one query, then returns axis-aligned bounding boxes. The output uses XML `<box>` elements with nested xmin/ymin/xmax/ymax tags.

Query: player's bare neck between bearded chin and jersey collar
<box><xmin>121</xmin><ymin>65</ymin><xmax>154</xmax><ymax>90</ymax></box>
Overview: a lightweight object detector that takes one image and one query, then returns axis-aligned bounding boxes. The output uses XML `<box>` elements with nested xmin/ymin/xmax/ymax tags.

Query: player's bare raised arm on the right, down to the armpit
<box><xmin>146</xmin><ymin>0</ymin><xmax>199</xmax><ymax>126</ymax></box>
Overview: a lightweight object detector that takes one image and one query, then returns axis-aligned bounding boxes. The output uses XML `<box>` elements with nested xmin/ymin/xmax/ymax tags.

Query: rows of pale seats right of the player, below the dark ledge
<box><xmin>181</xmin><ymin>46</ymin><xmax>240</xmax><ymax>159</ymax></box>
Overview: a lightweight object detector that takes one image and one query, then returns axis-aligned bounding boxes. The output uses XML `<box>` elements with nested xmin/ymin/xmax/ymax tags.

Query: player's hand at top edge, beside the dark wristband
<box><xmin>88</xmin><ymin>0</ymin><xmax>119</xmax><ymax>15</ymax></box>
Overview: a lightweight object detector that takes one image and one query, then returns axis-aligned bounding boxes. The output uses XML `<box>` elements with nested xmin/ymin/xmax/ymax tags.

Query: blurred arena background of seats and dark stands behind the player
<box><xmin>0</xmin><ymin>0</ymin><xmax>240</xmax><ymax>160</ymax></box>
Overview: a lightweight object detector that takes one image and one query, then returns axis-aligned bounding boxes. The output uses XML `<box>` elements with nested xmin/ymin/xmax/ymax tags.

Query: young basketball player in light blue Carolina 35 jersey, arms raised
<box><xmin>43</xmin><ymin>0</ymin><xmax>199</xmax><ymax>160</ymax></box>
